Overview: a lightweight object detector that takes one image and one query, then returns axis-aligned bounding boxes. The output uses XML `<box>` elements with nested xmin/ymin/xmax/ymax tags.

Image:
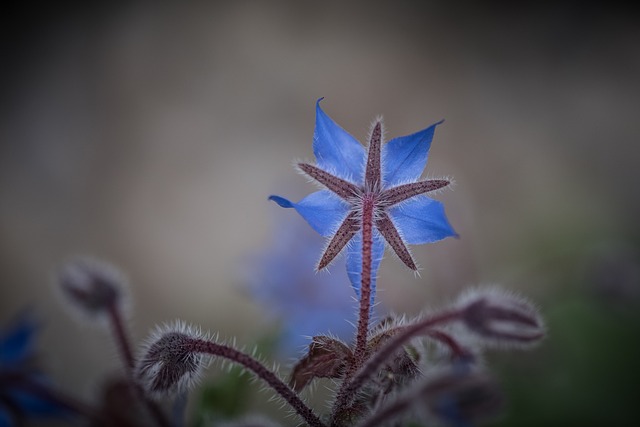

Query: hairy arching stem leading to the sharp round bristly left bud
<box><xmin>193</xmin><ymin>339</ymin><xmax>325</xmax><ymax>427</ymax></box>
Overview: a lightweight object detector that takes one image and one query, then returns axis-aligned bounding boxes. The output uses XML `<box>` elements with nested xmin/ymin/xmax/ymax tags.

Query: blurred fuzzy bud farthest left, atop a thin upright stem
<box><xmin>57</xmin><ymin>258</ymin><xmax>126</xmax><ymax>318</ymax></box>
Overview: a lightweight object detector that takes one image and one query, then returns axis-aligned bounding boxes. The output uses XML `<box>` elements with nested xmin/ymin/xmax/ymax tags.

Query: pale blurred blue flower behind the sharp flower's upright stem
<box><xmin>243</xmin><ymin>217</ymin><xmax>356</xmax><ymax>357</ymax></box>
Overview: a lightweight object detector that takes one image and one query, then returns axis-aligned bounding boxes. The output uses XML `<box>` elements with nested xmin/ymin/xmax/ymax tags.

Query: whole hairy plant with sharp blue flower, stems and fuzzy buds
<box><xmin>42</xmin><ymin>101</ymin><xmax>545</xmax><ymax>427</ymax></box>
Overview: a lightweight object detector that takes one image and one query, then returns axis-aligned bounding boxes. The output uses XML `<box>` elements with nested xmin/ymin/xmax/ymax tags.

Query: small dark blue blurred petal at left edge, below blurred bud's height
<box><xmin>0</xmin><ymin>313</ymin><xmax>37</xmax><ymax>366</ymax></box>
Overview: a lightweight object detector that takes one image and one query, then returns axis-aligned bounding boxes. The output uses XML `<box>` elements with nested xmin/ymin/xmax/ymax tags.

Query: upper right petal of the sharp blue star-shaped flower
<box><xmin>382</xmin><ymin>121</ymin><xmax>442</xmax><ymax>187</ymax></box>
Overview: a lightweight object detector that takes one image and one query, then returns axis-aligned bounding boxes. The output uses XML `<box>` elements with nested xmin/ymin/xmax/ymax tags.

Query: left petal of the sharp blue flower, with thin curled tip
<box><xmin>269</xmin><ymin>190</ymin><xmax>349</xmax><ymax>237</ymax></box>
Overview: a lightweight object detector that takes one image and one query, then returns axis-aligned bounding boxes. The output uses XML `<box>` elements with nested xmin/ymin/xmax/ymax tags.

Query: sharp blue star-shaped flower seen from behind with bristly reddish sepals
<box><xmin>269</xmin><ymin>99</ymin><xmax>456</xmax><ymax>295</ymax></box>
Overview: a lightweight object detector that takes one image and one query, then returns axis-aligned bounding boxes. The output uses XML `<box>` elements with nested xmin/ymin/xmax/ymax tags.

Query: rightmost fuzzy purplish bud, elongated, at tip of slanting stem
<box><xmin>457</xmin><ymin>287</ymin><xmax>545</xmax><ymax>347</ymax></box>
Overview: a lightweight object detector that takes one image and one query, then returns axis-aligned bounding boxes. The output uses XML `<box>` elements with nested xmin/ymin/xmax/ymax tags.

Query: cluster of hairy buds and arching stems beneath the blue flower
<box><xmin>127</xmin><ymin>287</ymin><xmax>544</xmax><ymax>426</ymax></box>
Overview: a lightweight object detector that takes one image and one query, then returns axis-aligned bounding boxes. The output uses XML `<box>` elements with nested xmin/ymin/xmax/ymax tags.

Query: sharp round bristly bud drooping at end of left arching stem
<box><xmin>136</xmin><ymin>321</ymin><xmax>209</xmax><ymax>397</ymax></box>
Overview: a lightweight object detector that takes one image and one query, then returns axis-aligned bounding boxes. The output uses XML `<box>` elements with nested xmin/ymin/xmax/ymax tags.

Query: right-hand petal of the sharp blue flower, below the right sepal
<box><xmin>389</xmin><ymin>196</ymin><xmax>458</xmax><ymax>245</ymax></box>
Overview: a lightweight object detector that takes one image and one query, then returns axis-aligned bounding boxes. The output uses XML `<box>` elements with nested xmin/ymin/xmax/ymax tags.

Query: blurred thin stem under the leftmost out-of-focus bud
<box><xmin>109</xmin><ymin>304</ymin><xmax>171</xmax><ymax>427</ymax></box>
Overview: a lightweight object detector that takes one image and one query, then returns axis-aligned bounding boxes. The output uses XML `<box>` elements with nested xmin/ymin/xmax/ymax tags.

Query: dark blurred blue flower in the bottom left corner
<box><xmin>0</xmin><ymin>312</ymin><xmax>67</xmax><ymax>427</ymax></box>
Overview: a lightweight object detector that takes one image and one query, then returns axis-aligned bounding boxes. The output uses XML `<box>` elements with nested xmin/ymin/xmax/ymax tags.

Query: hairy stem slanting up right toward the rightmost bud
<box><xmin>341</xmin><ymin>311</ymin><xmax>460</xmax><ymax>405</ymax></box>
